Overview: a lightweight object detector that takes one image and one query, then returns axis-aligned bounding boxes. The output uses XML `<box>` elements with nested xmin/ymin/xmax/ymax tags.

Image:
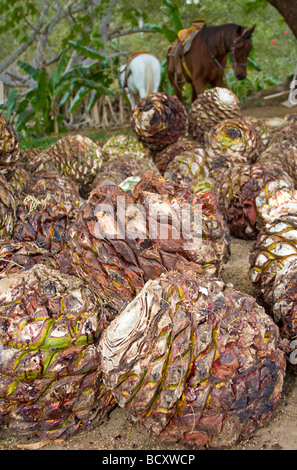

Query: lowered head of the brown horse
<box><xmin>230</xmin><ymin>25</ymin><xmax>256</xmax><ymax>80</ymax></box>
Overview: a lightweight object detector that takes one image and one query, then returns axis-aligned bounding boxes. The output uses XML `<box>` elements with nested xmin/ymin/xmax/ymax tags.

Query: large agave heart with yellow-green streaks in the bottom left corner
<box><xmin>0</xmin><ymin>264</ymin><xmax>115</xmax><ymax>439</ymax></box>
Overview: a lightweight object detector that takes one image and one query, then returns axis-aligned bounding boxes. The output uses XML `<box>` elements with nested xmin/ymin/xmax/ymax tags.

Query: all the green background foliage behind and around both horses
<box><xmin>0</xmin><ymin>0</ymin><xmax>297</xmax><ymax>135</ymax></box>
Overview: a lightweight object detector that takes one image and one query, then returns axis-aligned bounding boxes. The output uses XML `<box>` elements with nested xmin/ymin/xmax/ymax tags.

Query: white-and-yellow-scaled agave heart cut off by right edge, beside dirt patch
<box><xmin>249</xmin><ymin>213</ymin><xmax>297</xmax><ymax>307</ymax></box>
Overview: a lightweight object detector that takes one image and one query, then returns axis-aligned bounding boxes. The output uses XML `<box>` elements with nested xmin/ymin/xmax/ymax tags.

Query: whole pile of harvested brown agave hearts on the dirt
<box><xmin>0</xmin><ymin>88</ymin><xmax>297</xmax><ymax>449</ymax></box>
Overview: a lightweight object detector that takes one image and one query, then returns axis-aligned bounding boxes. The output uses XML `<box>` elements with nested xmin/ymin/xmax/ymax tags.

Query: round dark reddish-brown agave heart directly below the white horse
<box><xmin>131</xmin><ymin>93</ymin><xmax>187</xmax><ymax>151</ymax></box>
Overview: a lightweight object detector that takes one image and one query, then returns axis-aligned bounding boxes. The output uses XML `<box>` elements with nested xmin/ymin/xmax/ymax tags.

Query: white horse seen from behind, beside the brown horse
<box><xmin>119</xmin><ymin>53</ymin><xmax>161</xmax><ymax>108</ymax></box>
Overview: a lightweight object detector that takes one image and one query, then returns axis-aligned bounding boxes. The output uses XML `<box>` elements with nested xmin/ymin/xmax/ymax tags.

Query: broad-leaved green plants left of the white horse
<box><xmin>0</xmin><ymin>43</ymin><xmax>112</xmax><ymax>135</ymax></box>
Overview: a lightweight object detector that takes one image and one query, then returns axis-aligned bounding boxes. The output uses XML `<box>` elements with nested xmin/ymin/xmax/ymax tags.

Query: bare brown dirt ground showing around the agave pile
<box><xmin>0</xmin><ymin>100</ymin><xmax>297</xmax><ymax>451</ymax></box>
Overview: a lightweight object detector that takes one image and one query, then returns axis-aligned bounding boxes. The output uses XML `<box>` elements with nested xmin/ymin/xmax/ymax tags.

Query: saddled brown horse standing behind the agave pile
<box><xmin>167</xmin><ymin>23</ymin><xmax>255</xmax><ymax>102</ymax></box>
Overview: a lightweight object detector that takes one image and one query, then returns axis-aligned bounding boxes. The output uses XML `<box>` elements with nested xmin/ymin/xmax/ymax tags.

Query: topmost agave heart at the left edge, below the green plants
<box><xmin>0</xmin><ymin>114</ymin><xmax>20</xmax><ymax>176</ymax></box>
